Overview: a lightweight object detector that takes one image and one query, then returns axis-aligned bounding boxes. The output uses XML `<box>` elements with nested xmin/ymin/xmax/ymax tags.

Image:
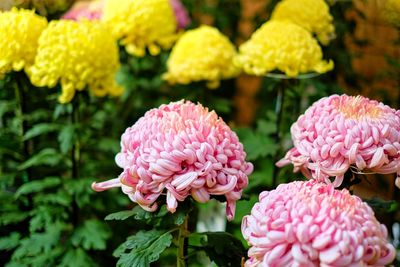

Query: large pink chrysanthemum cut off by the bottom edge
<box><xmin>242</xmin><ymin>180</ymin><xmax>396</xmax><ymax>267</ymax></box>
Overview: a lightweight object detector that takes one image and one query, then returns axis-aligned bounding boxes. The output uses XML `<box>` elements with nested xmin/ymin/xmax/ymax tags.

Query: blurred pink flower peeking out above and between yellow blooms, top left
<box><xmin>61</xmin><ymin>0</ymin><xmax>104</xmax><ymax>20</ymax></box>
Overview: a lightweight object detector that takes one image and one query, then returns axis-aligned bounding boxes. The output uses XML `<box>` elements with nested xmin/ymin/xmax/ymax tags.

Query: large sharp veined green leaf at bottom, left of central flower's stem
<box><xmin>114</xmin><ymin>230</ymin><xmax>172</xmax><ymax>267</ymax></box>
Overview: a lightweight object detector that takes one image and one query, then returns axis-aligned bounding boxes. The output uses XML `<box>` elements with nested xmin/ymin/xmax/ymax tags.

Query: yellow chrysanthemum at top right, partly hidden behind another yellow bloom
<box><xmin>272</xmin><ymin>0</ymin><xmax>335</xmax><ymax>45</ymax></box>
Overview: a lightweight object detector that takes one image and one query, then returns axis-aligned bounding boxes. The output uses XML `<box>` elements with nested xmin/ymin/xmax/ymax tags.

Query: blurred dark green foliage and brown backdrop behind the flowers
<box><xmin>0</xmin><ymin>0</ymin><xmax>400</xmax><ymax>267</ymax></box>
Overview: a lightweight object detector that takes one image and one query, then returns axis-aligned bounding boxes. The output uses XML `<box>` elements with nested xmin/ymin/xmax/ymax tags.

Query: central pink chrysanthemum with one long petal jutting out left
<box><xmin>92</xmin><ymin>101</ymin><xmax>253</xmax><ymax>220</ymax></box>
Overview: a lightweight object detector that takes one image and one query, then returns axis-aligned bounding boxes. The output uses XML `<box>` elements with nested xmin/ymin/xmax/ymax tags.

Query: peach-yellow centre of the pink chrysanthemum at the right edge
<box><xmin>334</xmin><ymin>96</ymin><xmax>381</xmax><ymax>120</ymax></box>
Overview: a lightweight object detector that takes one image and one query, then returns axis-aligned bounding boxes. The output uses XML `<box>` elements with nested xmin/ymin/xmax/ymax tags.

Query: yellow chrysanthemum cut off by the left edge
<box><xmin>0</xmin><ymin>8</ymin><xmax>47</xmax><ymax>78</ymax></box>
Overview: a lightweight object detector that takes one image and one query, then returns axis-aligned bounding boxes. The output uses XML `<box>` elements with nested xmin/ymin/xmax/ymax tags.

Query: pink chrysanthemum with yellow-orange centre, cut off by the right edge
<box><xmin>277</xmin><ymin>95</ymin><xmax>400</xmax><ymax>186</ymax></box>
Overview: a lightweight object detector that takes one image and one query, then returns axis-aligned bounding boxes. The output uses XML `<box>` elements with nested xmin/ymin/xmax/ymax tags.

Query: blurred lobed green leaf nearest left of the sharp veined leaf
<box><xmin>71</xmin><ymin>220</ymin><xmax>111</xmax><ymax>250</ymax></box>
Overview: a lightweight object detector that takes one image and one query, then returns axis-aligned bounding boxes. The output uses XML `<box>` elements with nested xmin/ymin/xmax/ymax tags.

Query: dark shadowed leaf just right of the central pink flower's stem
<box><xmin>190</xmin><ymin>232</ymin><xmax>246</xmax><ymax>267</ymax></box>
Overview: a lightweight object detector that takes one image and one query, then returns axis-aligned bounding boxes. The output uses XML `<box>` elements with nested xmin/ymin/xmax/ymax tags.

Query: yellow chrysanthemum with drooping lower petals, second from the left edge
<box><xmin>28</xmin><ymin>20</ymin><xmax>122</xmax><ymax>103</ymax></box>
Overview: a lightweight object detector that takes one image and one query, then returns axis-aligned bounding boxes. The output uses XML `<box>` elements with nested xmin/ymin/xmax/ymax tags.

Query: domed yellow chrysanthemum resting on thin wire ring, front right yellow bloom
<box><xmin>236</xmin><ymin>21</ymin><xmax>333</xmax><ymax>77</ymax></box>
